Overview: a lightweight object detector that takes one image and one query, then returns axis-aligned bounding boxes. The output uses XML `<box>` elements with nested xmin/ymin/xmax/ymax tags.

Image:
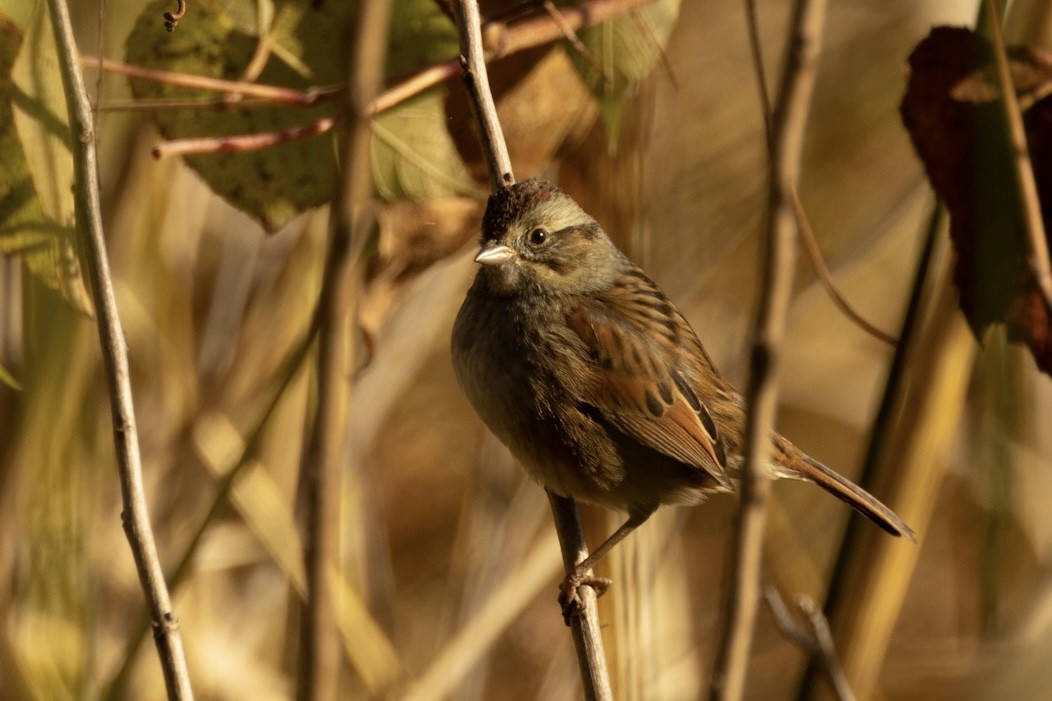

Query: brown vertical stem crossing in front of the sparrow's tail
<box><xmin>711</xmin><ymin>0</ymin><xmax>826</xmax><ymax>701</ymax></box>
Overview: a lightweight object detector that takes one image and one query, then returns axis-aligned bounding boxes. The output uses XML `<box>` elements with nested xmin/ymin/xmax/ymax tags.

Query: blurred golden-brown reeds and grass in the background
<box><xmin>0</xmin><ymin>0</ymin><xmax>1052</xmax><ymax>701</ymax></box>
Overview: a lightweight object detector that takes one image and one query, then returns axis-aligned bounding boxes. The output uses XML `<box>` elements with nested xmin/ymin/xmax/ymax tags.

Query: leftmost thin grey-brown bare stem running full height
<box><xmin>47</xmin><ymin>0</ymin><xmax>194</xmax><ymax>699</ymax></box>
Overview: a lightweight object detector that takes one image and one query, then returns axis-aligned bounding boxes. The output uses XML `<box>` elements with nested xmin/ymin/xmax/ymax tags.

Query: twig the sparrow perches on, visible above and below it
<box><xmin>453</xmin><ymin>0</ymin><xmax>612</xmax><ymax>701</ymax></box>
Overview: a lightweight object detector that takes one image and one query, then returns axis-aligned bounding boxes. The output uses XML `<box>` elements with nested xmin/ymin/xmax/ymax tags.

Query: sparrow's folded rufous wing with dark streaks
<box><xmin>567</xmin><ymin>267</ymin><xmax>730</xmax><ymax>486</ymax></box>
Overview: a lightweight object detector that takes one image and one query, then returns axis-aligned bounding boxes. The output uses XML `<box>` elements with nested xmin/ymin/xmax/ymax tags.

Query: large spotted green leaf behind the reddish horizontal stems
<box><xmin>125</xmin><ymin>0</ymin><xmax>350</xmax><ymax>232</ymax></box>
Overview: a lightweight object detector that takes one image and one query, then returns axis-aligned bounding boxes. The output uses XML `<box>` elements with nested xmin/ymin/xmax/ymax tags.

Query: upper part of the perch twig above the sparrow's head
<box><xmin>453</xmin><ymin>0</ymin><xmax>515</xmax><ymax>191</ymax></box>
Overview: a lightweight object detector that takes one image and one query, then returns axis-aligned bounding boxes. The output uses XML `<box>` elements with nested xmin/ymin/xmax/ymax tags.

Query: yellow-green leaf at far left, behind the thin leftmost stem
<box><xmin>0</xmin><ymin>8</ymin><xmax>93</xmax><ymax>315</ymax></box>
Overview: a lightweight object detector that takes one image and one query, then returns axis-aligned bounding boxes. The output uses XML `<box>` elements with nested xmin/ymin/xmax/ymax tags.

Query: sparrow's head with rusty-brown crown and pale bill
<box><xmin>474</xmin><ymin>180</ymin><xmax>623</xmax><ymax>295</ymax></box>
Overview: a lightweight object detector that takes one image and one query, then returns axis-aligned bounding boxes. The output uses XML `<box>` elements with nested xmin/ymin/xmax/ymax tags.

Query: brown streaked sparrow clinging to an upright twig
<box><xmin>451</xmin><ymin>180</ymin><xmax>915</xmax><ymax>616</ymax></box>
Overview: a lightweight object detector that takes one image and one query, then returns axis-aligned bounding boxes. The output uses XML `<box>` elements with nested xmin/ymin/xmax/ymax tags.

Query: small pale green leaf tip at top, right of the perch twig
<box><xmin>566</xmin><ymin>0</ymin><xmax>680</xmax><ymax>142</ymax></box>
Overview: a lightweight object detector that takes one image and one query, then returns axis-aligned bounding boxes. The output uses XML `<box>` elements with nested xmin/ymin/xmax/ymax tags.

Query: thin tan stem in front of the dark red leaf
<box><xmin>986</xmin><ymin>0</ymin><xmax>1052</xmax><ymax>309</ymax></box>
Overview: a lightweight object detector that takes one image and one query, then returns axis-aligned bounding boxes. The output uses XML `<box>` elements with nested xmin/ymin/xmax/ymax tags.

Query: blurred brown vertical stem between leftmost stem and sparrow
<box><xmin>297</xmin><ymin>0</ymin><xmax>390</xmax><ymax>701</ymax></box>
